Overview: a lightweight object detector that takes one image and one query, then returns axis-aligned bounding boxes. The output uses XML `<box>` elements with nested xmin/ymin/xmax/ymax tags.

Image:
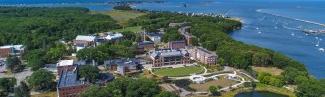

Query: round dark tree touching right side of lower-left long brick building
<box><xmin>79</xmin><ymin>65</ymin><xmax>99</xmax><ymax>82</ymax></box>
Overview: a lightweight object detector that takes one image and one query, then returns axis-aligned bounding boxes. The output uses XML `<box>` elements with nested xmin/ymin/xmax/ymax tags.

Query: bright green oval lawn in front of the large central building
<box><xmin>153</xmin><ymin>66</ymin><xmax>204</xmax><ymax>77</ymax></box>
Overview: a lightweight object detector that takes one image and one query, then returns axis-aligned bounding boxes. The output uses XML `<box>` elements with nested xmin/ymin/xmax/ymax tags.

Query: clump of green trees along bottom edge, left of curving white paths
<box><xmin>81</xmin><ymin>78</ymin><xmax>162</xmax><ymax>97</ymax></box>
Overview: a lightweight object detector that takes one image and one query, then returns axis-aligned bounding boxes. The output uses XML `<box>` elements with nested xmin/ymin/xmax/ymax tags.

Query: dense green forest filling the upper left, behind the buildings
<box><xmin>0</xmin><ymin>7</ymin><xmax>121</xmax><ymax>49</ymax></box>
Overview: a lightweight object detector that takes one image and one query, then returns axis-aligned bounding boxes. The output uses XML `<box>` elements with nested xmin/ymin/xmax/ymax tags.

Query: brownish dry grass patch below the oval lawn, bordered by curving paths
<box><xmin>190</xmin><ymin>77</ymin><xmax>237</xmax><ymax>92</ymax></box>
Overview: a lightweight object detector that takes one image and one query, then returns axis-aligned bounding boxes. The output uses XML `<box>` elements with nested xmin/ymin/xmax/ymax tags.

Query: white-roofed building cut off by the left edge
<box><xmin>0</xmin><ymin>45</ymin><xmax>25</xmax><ymax>58</ymax></box>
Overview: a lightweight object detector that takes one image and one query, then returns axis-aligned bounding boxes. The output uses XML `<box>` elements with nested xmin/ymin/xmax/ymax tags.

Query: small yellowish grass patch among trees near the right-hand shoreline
<box><xmin>253</xmin><ymin>66</ymin><xmax>283</xmax><ymax>75</ymax></box>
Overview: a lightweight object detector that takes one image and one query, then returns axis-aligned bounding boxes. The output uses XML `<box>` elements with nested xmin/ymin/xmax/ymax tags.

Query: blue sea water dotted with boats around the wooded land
<box><xmin>0</xmin><ymin>0</ymin><xmax>325</xmax><ymax>78</ymax></box>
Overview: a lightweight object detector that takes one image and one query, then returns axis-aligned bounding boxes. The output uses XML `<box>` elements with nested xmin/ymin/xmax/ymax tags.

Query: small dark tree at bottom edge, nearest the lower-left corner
<box><xmin>14</xmin><ymin>82</ymin><xmax>30</xmax><ymax>97</ymax></box>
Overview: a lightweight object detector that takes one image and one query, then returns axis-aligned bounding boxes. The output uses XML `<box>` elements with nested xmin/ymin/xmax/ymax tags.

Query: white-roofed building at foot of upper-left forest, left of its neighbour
<box><xmin>74</xmin><ymin>35</ymin><xmax>97</xmax><ymax>51</ymax></box>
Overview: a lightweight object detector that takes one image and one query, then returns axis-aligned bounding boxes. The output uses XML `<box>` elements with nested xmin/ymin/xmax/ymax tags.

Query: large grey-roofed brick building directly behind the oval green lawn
<box><xmin>148</xmin><ymin>49</ymin><xmax>190</xmax><ymax>67</ymax></box>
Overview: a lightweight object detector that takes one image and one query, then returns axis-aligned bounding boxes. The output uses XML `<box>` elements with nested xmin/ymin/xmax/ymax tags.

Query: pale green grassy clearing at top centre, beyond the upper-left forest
<box><xmin>105</xmin><ymin>10</ymin><xmax>146</xmax><ymax>26</ymax></box>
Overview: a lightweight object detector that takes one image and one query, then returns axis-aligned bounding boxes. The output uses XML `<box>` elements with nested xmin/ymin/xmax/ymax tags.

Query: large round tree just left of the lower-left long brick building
<box><xmin>27</xmin><ymin>69</ymin><xmax>55</xmax><ymax>90</ymax></box>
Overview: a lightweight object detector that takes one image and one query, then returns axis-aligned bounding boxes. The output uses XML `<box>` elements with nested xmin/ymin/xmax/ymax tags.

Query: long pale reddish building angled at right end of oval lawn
<box><xmin>189</xmin><ymin>47</ymin><xmax>218</xmax><ymax>65</ymax></box>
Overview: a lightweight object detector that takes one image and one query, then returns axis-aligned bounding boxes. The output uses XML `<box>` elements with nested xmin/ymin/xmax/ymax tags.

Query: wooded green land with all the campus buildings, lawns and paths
<box><xmin>0</xmin><ymin>1</ymin><xmax>325</xmax><ymax>97</ymax></box>
